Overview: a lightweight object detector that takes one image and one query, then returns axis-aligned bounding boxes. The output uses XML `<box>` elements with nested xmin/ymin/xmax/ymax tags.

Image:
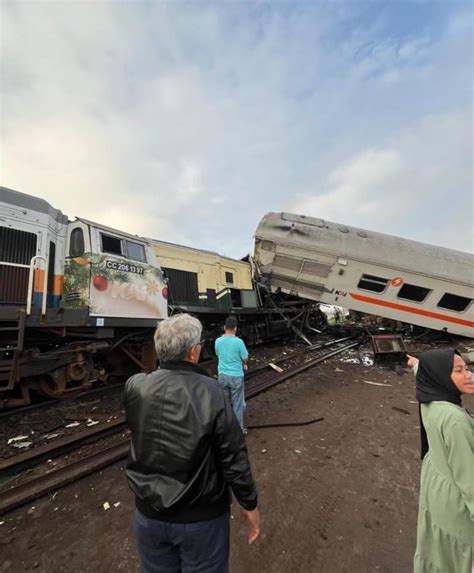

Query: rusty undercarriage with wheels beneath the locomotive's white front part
<box><xmin>0</xmin><ymin>309</ymin><xmax>156</xmax><ymax>408</ymax></box>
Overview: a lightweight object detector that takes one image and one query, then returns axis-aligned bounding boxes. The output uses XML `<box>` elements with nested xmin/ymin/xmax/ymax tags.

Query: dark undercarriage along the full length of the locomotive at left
<box><xmin>0</xmin><ymin>297</ymin><xmax>330</xmax><ymax>408</ymax></box>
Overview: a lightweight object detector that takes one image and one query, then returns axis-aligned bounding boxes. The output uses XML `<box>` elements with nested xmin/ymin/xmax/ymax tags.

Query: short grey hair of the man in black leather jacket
<box><xmin>155</xmin><ymin>314</ymin><xmax>202</xmax><ymax>363</ymax></box>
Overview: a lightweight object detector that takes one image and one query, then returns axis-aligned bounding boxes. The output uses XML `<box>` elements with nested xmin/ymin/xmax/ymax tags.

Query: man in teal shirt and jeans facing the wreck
<box><xmin>214</xmin><ymin>316</ymin><xmax>249</xmax><ymax>431</ymax></box>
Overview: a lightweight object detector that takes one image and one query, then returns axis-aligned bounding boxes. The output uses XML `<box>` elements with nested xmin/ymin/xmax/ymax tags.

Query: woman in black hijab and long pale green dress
<box><xmin>409</xmin><ymin>349</ymin><xmax>474</xmax><ymax>573</ymax></box>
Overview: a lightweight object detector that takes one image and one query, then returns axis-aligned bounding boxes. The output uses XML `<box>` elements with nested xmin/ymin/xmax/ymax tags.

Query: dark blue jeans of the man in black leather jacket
<box><xmin>133</xmin><ymin>509</ymin><xmax>230</xmax><ymax>573</ymax></box>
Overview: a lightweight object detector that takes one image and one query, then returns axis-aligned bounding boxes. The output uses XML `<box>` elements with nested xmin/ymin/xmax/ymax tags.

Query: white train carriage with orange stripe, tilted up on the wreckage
<box><xmin>253</xmin><ymin>213</ymin><xmax>474</xmax><ymax>338</ymax></box>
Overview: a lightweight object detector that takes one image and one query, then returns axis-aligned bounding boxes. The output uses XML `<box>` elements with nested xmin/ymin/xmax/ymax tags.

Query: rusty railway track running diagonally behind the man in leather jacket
<box><xmin>0</xmin><ymin>339</ymin><xmax>359</xmax><ymax>515</ymax></box>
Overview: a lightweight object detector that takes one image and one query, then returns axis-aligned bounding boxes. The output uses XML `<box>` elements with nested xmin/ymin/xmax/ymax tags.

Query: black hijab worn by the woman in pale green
<box><xmin>416</xmin><ymin>348</ymin><xmax>461</xmax><ymax>459</ymax></box>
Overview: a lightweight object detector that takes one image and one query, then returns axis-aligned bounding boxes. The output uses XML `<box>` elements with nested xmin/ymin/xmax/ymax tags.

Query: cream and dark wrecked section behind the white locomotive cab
<box><xmin>148</xmin><ymin>239</ymin><xmax>314</xmax><ymax>346</ymax></box>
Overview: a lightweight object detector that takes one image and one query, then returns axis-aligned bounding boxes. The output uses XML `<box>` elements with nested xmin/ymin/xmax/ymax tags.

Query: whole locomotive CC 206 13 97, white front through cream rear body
<box><xmin>0</xmin><ymin>187</ymin><xmax>315</xmax><ymax>408</ymax></box>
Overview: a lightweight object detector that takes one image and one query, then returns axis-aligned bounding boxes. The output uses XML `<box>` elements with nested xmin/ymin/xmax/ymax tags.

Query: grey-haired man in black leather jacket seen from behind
<box><xmin>124</xmin><ymin>314</ymin><xmax>260</xmax><ymax>573</ymax></box>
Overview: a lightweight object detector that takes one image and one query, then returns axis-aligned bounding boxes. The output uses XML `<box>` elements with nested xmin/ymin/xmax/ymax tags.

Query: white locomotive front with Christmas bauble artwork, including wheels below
<box><xmin>0</xmin><ymin>187</ymin><xmax>168</xmax><ymax>407</ymax></box>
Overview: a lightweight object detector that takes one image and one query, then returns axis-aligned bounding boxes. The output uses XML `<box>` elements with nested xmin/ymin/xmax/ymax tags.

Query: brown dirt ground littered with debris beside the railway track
<box><xmin>0</xmin><ymin>355</ymin><xmax>474</xmax><ymax>573</ymax></box>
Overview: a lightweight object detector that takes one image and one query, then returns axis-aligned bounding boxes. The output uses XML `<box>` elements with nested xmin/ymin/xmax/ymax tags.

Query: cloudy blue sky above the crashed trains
<box><xmin>0</xmin><ymin>0</ymin><xmax>474</xmax><ymax>258</ymax></box>
